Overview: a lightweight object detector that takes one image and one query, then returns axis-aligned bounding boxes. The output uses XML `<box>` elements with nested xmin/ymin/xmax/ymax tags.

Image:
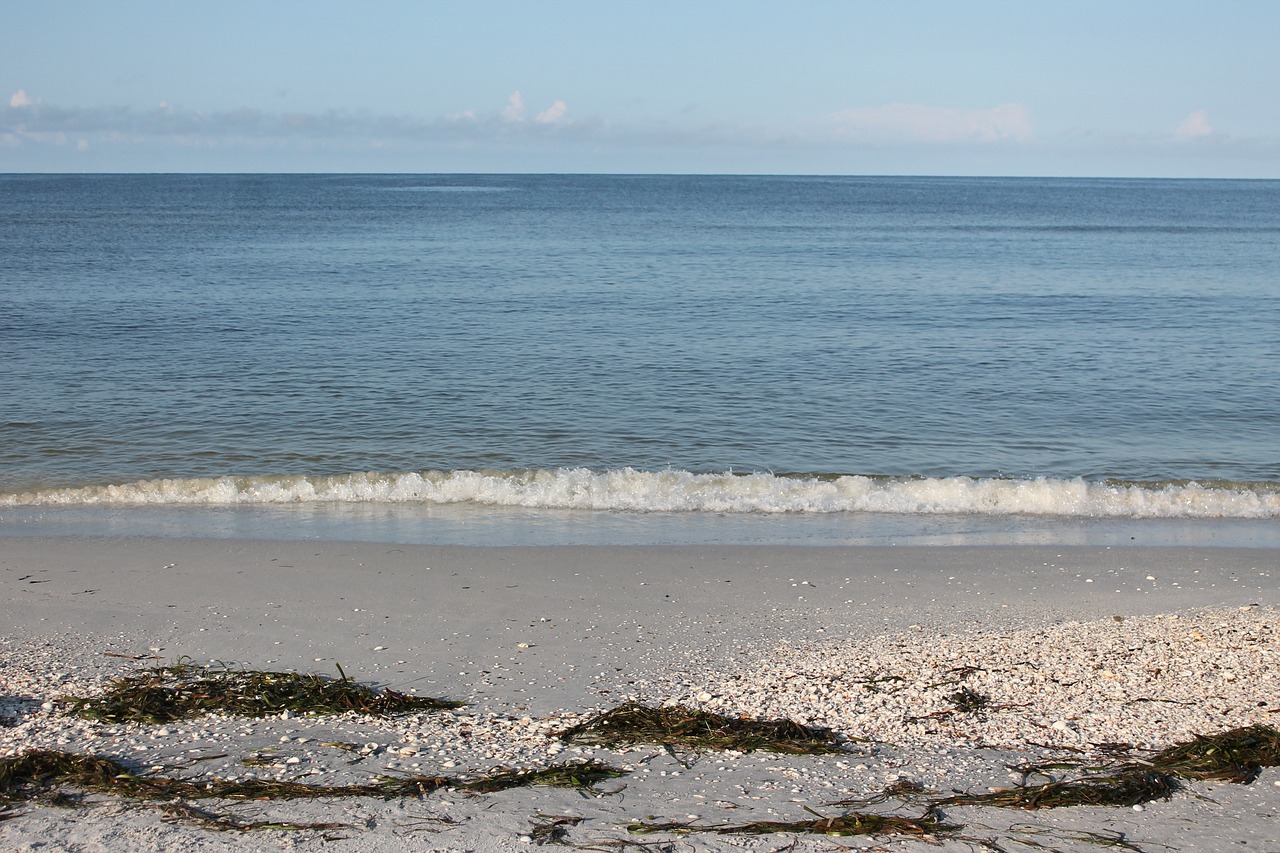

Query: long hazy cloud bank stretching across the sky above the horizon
<box><xmin>10</xmin><ymin>90</ymin><xmax>1280</xmax><ymax>177</ymax></box>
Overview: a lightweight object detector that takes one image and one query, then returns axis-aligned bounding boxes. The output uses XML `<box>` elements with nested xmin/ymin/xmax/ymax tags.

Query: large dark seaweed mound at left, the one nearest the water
<box><xmin>63</xmin><ymin>658</ymin><xmax>462</xmax><ymax>722</ymax></box>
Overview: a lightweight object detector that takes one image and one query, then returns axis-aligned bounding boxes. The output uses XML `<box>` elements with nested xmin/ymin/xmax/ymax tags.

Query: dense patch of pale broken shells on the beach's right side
<box><xmin>673</xmin><ymin>607</ymin><xmax>1280</xmax><ymax>749</ymax></box>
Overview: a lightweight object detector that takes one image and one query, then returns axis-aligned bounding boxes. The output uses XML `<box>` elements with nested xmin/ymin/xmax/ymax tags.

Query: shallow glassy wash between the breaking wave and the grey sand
<box><xmin>0</xmin><ymin>502</ymin><xmax>1280</xmax><ymax>548</ymax></box>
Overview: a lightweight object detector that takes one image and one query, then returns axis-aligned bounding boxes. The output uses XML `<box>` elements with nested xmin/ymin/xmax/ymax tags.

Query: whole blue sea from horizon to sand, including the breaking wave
<box><xmin>0</xmin><ymin>174</ymin><xmax>1280</xmax><ymax>544</ymax></box>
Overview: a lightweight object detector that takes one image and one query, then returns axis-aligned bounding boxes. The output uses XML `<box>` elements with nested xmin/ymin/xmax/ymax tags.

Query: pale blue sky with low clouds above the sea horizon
<box><xmin>0</xmin><ymin>0</ymin><xmax>1280</xmax><ymax>178</ymax></box>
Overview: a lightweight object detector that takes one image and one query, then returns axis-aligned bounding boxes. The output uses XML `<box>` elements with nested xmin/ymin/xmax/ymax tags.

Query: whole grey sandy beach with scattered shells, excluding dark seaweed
<box><xmin>0</xmin><ymin>537</ymin><xmax>1280</xmax><ymax>850</ymax></box>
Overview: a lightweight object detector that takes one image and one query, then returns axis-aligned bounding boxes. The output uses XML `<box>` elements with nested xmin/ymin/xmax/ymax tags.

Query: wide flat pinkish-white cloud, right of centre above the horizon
<box><xmin>832</xmin><ymin>104</ymin><xmax>1032</xmax><ymax>142</ymax></box>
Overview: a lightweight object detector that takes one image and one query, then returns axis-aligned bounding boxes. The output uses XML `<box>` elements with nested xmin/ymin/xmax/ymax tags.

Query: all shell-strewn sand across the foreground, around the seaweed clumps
<box><xmin>0</xmin><ymin>606</ymin><xmax>1280</xmax><ymax>850</ymax></box>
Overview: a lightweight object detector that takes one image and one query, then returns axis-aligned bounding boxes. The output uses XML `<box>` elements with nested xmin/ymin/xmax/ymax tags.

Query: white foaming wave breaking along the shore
<box><xmin>0</xmin><ymin>467</ymin><xmax>1280</xmax><ymax>519</ymax></box>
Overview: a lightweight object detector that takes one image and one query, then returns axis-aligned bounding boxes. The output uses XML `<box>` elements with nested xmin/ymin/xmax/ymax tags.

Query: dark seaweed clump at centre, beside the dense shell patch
<box><xmin>557</xmin><ymin>702</ymin><xmax>845</xmax><ymax>754</ymax></box>
